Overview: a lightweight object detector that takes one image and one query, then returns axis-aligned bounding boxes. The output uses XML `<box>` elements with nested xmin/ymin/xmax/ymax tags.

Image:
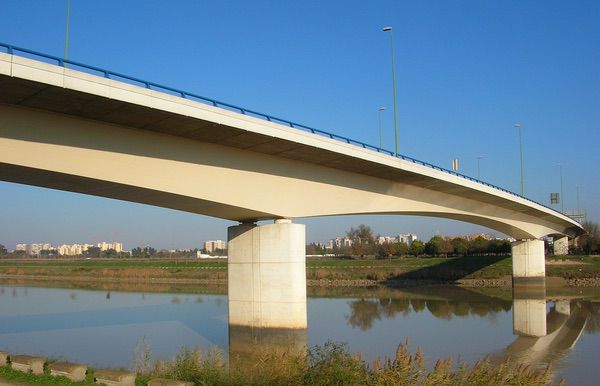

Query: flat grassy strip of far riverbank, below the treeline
<box><xmin>0</xmin><ymin>256</ymin><xmax>600</xmax><ymax>287</ymax></box>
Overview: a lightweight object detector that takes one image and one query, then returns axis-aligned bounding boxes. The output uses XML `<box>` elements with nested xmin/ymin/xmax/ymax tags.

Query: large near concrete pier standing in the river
<box><xmin>227</xmin><ymin>219</ymin><xmax>307</xmax><ymax>329</ymax></box>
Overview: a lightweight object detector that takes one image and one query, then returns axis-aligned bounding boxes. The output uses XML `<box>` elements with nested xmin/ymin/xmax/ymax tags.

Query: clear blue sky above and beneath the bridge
<box><xmin>0</xmin><ymin>0</ymin><xmax>600</xmax><ymax>248</ymax></box>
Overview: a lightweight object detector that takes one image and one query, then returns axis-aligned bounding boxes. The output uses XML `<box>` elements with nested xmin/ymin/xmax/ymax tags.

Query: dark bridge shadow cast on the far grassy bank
<box><xmin>385</xmin><ymin>255</ymin><xmax>510</xmax><ymax>287</ymax></box>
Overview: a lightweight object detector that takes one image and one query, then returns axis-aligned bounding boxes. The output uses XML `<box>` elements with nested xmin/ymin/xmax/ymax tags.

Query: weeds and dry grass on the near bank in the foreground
<box><xmin>0</xmin><ymin>343</ymin><xmax>552</xmax><ymax>386</ymax></box>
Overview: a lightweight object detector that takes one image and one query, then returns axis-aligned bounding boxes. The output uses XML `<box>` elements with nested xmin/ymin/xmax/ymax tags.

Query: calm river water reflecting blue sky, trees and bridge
<box><xmin>0</xmin><ymin>284</ymin><xmax>600</xmax><ymax>385</ymax></box>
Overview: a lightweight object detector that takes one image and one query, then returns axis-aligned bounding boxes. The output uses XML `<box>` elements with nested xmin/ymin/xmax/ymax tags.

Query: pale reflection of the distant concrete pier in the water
<box><xmin>513</xmin><ymin>285</ymin><xmax>547</xmax><ymax>337</ymax></box>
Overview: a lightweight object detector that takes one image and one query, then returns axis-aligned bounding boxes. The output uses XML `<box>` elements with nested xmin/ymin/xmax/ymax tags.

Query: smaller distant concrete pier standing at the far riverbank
<box><xmin>511</xmin><ymin>240</ymin><xmax>546</xmax><ymax>283</ymax></box>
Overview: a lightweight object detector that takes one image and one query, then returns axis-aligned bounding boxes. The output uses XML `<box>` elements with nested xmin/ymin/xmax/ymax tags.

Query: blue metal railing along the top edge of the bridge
<box><xmin>0</xmin><ymin>42</ymin><xmax>560</xmax><ymax>213</ymax></box>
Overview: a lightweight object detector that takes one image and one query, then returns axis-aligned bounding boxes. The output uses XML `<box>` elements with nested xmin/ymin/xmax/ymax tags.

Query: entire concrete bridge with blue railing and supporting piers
<box><xmin>0</xmin><ymin>43</ymin><xmax>583</xmax><ymax>328</ymax></box>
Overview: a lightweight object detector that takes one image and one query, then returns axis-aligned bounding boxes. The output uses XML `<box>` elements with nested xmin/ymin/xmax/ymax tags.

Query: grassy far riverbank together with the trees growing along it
<box><xmin>0</xmin><ymin>222</ymin><xmax>600</xmax><ymax>286</ymax></box>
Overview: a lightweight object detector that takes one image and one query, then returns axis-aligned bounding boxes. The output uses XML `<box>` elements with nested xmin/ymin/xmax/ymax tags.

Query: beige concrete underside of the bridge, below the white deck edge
<box><xmin>0</xmin><ymin>105</ymin><xmax>570</xmax><ymax>239</ymax></box>
